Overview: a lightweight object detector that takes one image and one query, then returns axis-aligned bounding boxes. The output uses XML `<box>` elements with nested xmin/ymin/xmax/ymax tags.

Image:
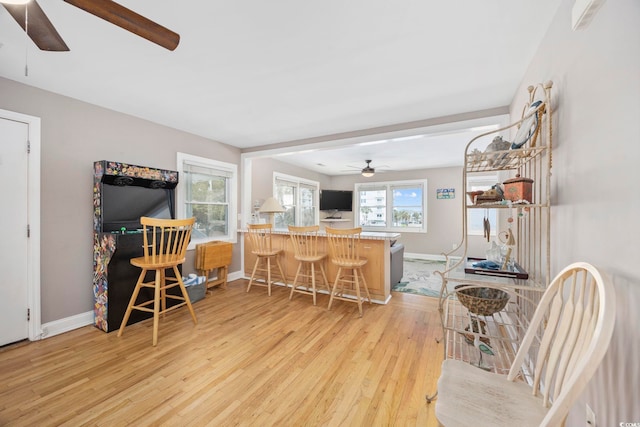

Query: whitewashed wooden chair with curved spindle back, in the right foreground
<box><xmin>436</xmin><ymin>262</ymin><xmax>615</xmax><ymax>427</ymax></box>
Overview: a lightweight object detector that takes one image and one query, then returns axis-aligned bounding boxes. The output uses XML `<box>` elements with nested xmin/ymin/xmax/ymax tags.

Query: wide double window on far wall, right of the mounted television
<box><xmin>355</xmin><ymin>180</ymin><xmax>427</xmax><ymax>233</ymax></box>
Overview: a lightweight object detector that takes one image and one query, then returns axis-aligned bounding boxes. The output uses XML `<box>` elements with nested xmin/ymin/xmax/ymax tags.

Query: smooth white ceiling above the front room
<box><xmin>0</xmin><ymin>0</ymin><xmax>569</xmax><ymax>174</ymax></box>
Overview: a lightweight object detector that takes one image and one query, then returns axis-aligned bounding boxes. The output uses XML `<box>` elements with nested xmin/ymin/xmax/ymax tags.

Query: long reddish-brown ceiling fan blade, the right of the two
<box><xmin>64</xmin><ymin>0</ymin><xmax>180</xmax><ymax>50</ymax></box>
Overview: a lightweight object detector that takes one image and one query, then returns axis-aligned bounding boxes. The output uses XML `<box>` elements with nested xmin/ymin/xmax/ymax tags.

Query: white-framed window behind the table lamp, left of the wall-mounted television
<box><xmin>274</xmin><ymin>173</ymin><xmax>320</xmax><ymax>229</ymax></box>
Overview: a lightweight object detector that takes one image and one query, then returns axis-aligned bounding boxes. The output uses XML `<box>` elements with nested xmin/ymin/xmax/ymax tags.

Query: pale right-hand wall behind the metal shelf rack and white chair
<box><xmin>512</xmin><ymin>0</ymin><xmax>640</xmax><ymax>427</ymax></box>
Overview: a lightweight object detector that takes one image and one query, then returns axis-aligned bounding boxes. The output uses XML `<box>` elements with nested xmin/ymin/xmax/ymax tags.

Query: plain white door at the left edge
<box><xmin>0</xmin><ymin>118</ymin><xmax>29</xmax><ymax>345</ymax></box>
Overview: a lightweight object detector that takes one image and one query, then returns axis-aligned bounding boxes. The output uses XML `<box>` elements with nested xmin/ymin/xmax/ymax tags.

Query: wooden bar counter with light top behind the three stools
<box><xmin>244</xmin><ymin>230</ymin><xmax>400</xmax><ymax>304</ymax></box>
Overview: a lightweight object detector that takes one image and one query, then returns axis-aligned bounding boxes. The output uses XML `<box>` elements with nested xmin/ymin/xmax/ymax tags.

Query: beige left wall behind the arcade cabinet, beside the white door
<box><xmin>0</xmin><ymin>78</ymin><xmax>240</xmax><ymax>323</ymax></box>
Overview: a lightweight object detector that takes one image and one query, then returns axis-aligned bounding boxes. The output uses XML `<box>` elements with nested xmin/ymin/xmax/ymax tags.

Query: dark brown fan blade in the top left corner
<box><xmin>2</xmin><ymin>0</ymin><xmax>69</xmax><ymax>52</ymax></box>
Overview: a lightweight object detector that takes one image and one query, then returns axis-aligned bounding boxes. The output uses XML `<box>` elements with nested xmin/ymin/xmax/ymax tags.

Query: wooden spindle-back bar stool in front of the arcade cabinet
<box><xmin>118</xmin><ymin>217</ymin><xmax>198</xmax><ymax>346</ymax></box>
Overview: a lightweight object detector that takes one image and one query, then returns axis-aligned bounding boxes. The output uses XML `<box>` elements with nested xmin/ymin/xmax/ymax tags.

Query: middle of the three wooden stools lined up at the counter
<box><xmin>289</xmin><ymin>225</ymin><xmax>331</xmax><ymax>305</ymax></box>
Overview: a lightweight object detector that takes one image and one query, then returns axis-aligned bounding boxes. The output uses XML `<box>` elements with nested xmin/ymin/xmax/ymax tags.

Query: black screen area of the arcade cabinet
<box><xmin>101</xmin><ymin>176</ymin><xmax>175</xmax><ymax>233</ymax></box>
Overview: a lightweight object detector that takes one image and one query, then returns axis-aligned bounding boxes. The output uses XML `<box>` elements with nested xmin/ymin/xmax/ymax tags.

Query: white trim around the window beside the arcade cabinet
<box><xmin>176</xmin><ymin>152</ymin><xmax>238</xmax><ymax>250</ymax></box>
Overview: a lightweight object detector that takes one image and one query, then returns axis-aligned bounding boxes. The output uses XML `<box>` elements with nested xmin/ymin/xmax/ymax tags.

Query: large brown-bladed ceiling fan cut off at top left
<box><xmin>0</xmin><ymin>0</ymin><xmax>180</xmax><ymax>52</ymax></box>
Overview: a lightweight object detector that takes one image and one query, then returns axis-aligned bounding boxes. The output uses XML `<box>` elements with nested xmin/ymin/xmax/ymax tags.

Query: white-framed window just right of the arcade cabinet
<box><xmin>177</xmin><ymin>153</ymin><xmax>238</xmax><ymax>249</ymax></box>
